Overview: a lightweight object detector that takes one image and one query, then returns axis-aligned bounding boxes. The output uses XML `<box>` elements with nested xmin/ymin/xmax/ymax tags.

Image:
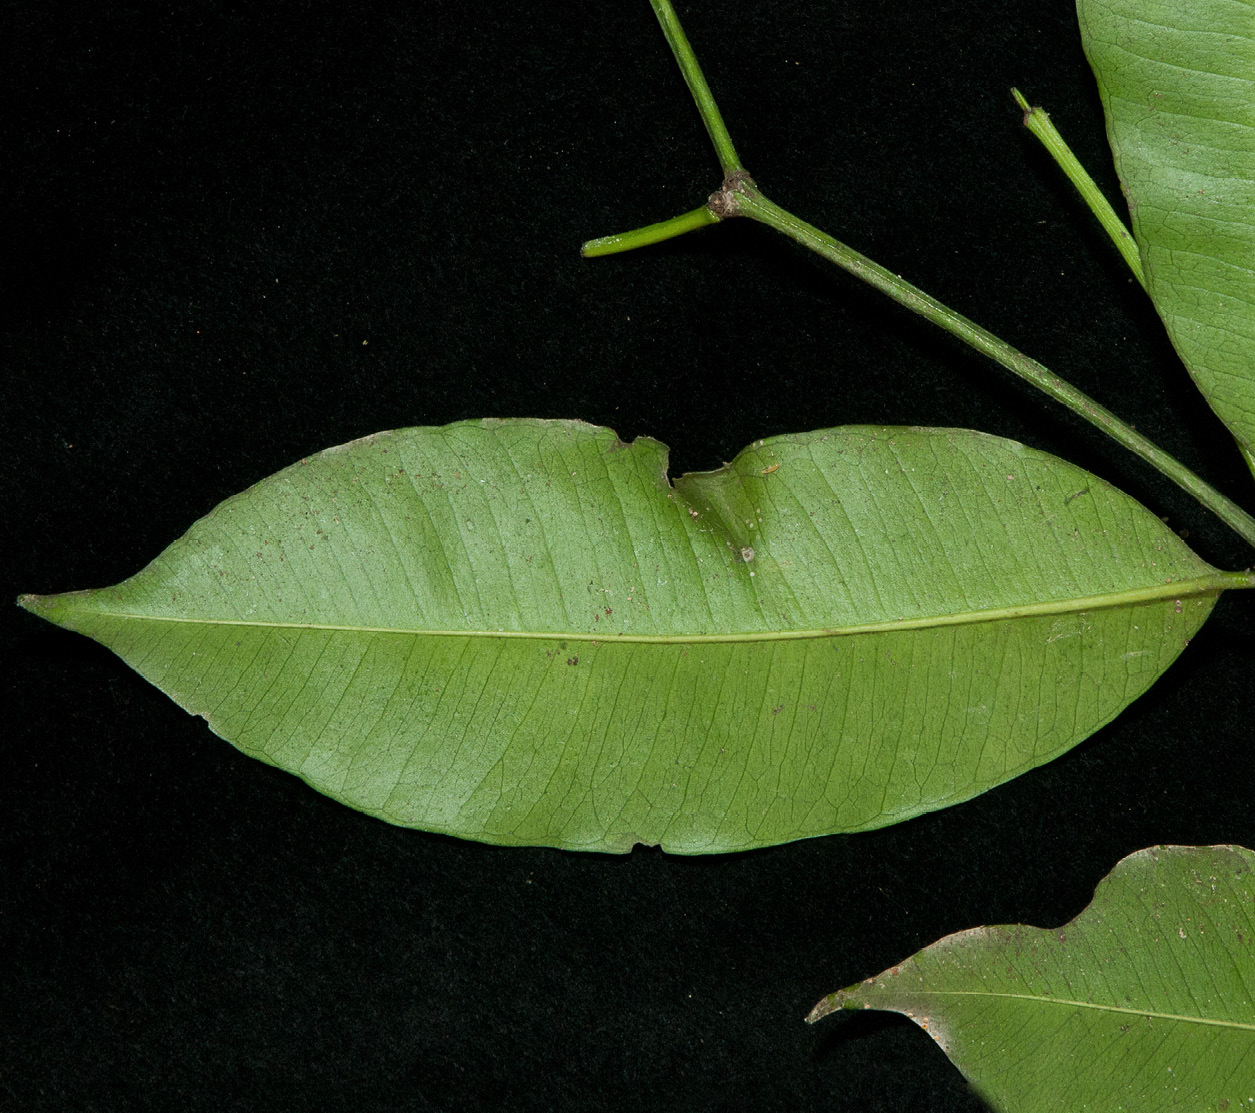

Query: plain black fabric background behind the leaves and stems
<box><xmin>0</xmin><ymin>0</ymin><xmax>1255</xmax><ymax>1113</ymax></box>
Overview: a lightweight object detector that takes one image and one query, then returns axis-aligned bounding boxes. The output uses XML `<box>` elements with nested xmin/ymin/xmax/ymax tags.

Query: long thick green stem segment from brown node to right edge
<box><xmin>737</xmin><ymin>191</ymin><xmax>1255</xmax><ymax>557</ymax></box>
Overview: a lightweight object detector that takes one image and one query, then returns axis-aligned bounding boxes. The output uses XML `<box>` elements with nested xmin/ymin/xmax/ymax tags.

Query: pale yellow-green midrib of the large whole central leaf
<box><xmin>36</xmin><ymin>572</ymin><xmax>1234</xmax><ymax>645</ymax></box>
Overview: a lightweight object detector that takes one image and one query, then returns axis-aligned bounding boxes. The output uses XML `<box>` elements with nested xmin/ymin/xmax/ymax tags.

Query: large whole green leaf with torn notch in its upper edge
<box><xmin>23</xmin><ymin>420</ymin><xmax>1232</xmax><ymax>853</ymax></box>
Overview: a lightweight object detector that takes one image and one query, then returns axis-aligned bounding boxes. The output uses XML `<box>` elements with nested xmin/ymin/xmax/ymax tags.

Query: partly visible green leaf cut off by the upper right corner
<box><xmin>1077</xmin><ymin>0</ymin><xmax>1255</xmax><ymax>471</ymax></box>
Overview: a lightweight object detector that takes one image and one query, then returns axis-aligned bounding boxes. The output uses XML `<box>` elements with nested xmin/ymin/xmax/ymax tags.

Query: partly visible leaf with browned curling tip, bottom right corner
<box><xmin>808</xmin><ymin>847</ymin><xmax>1255</xmax><ymax>1113</ymax></box>
